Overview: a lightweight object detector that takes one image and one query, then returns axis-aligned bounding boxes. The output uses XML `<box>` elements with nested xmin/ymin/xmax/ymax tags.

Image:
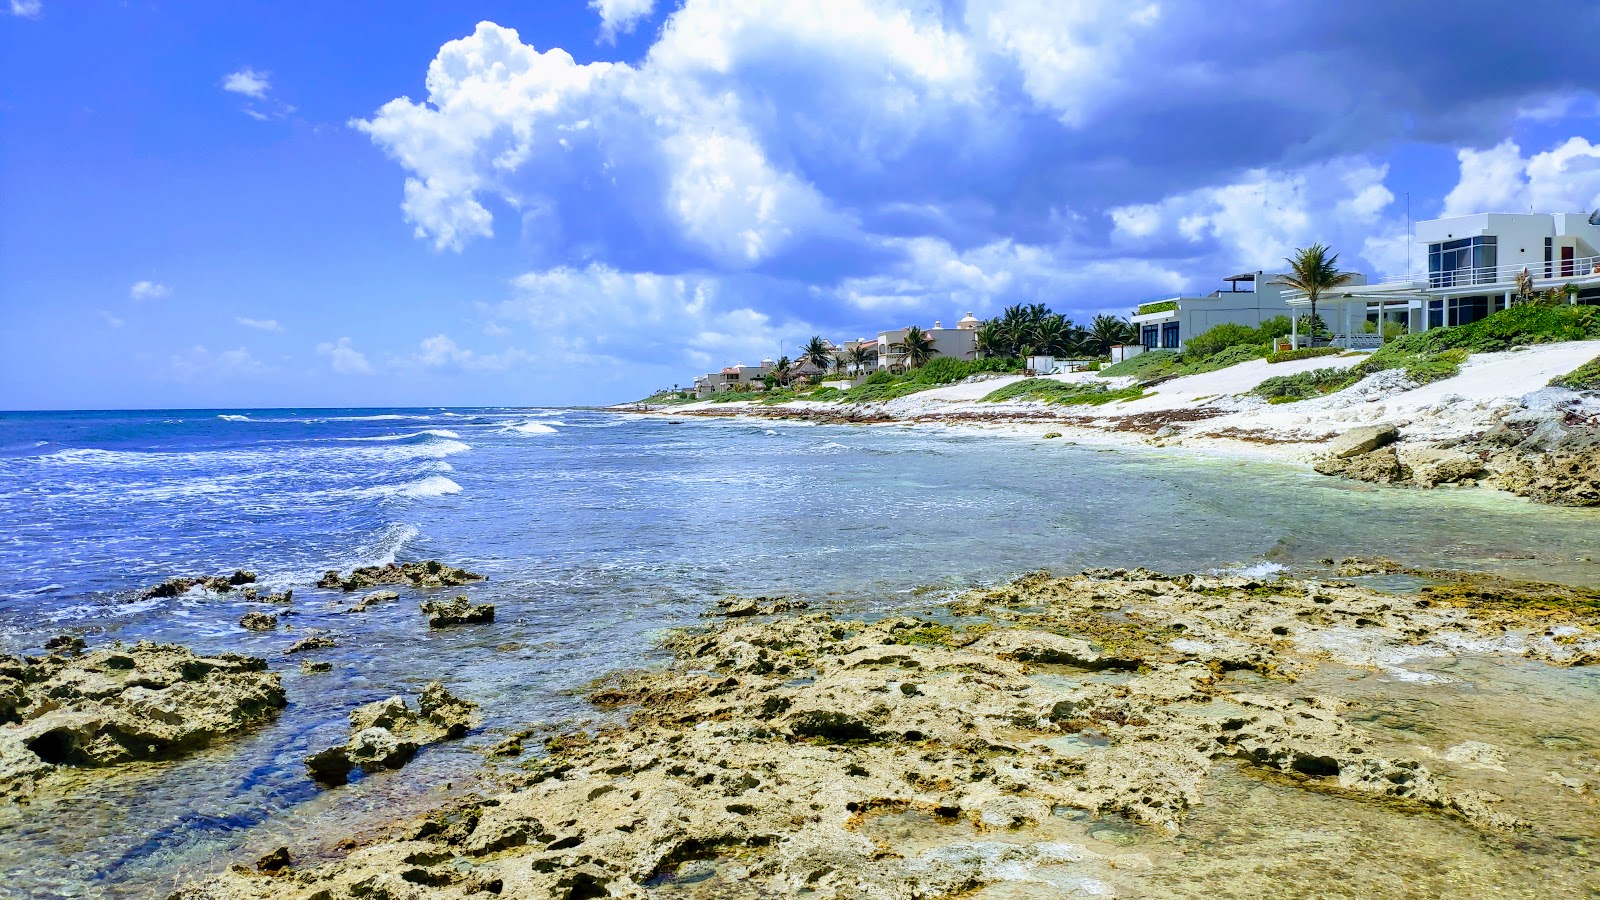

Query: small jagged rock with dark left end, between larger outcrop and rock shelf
<box><xmin>306</xmin><ymin>681</ymin><xmax>477</xmax><ymax>785</ymax></box>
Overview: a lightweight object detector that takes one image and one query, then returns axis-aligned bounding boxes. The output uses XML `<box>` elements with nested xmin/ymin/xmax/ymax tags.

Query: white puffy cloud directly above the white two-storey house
<box><xmin>1443</xmin><ymin>138</ymin><xmax>1600</xmax><ymax>216</ymax></box>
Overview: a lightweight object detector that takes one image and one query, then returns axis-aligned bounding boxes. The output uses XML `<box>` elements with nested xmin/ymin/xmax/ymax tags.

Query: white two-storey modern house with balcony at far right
<box><xmin>1288</xmin><ymin>211</ymin><xmax>1600</xmax><ymax>348</ymax></box>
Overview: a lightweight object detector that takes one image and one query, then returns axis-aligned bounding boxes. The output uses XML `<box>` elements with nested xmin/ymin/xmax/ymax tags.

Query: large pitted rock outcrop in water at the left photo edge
<box><xmin>0</xmin><ymin>642</ymin><xmax>286</xmax><ymax>796</ymax></box>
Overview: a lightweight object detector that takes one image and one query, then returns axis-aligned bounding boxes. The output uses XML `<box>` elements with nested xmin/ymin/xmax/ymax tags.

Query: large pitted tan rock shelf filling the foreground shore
<box><xmin>174</xmin><ymin>560</ymin><xmax>1600</xmax><ymax>900</ymax></box>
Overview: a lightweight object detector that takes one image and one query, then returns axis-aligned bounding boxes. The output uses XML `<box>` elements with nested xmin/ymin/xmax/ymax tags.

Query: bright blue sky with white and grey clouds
<box><xmin>0</xmin><ymin>0</ymin><xmax>1600</xmax><ymax>410</ymax></box>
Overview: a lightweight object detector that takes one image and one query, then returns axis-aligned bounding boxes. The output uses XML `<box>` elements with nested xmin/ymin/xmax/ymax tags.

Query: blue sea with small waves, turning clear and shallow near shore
<box><xmin>0</xmin><ymin>410</ymin><xmax>1600</xmax><ymax>895</ymax></box>
